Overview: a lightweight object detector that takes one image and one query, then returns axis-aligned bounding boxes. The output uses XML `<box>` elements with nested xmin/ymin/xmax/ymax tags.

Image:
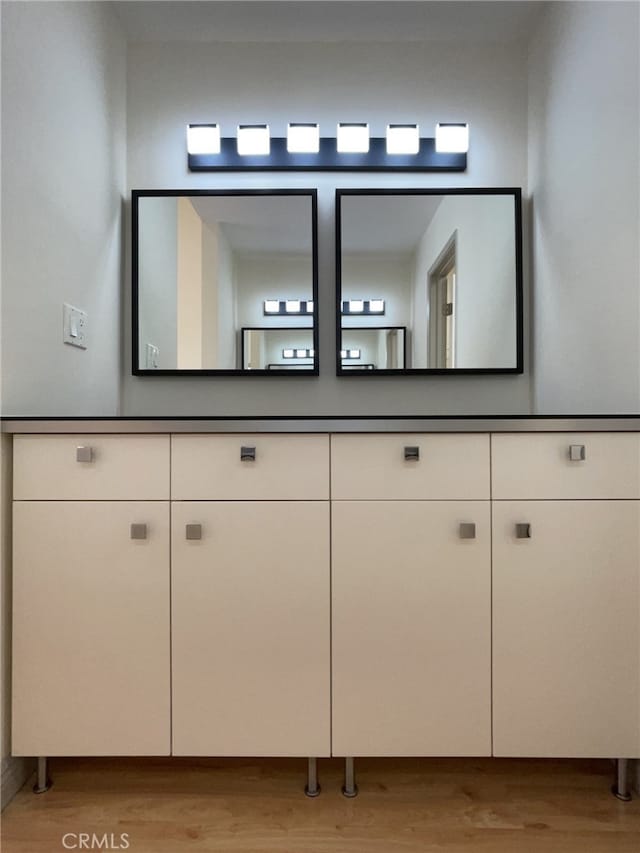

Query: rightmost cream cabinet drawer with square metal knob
<box><xmin>491</xmin><ymin>433</ymin><xmax>640</xmax><ymax>500</ymax></box>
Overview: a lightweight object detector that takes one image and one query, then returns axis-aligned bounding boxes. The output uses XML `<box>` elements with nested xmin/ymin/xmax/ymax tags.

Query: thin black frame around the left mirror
<box><xmin>131</xmin><ymin>187</ymin><xmax>320</xmax><ymax>377</ymax></box>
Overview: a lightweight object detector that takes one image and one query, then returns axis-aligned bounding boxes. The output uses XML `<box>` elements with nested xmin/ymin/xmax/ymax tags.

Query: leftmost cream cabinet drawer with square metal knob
<box><xmin>13</xmin><ymin>435</ymin><xmax>169</xmax><ymax>500</ymax></box>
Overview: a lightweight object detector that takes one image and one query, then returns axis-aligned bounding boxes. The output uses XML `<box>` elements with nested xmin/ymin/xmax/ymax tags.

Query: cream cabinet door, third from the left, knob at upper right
<box><xmin>332</xmin><ymin>501</ymin><xmax>491</xmax><ymax>756</ymax></box>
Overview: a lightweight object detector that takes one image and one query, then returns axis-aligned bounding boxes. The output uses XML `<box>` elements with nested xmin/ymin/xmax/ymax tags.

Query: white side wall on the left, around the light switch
<box><xmin>2</xmin><ymin>2</ymin><xmax>126</xmax><ymax>415</ymax></box>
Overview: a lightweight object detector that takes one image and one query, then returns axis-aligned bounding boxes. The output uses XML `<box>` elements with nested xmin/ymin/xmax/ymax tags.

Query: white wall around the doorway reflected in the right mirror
<box><xmin>413</xmin><ymin>195</ymin><xmax>517</xmax><ymax>368</ymax></box>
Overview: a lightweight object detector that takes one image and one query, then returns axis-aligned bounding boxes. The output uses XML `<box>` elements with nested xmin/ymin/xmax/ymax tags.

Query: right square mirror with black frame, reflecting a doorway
<box><xmin>336</xmin><ymin>188</ymin><xmax>523</xmax><ymax>375</ymax></box>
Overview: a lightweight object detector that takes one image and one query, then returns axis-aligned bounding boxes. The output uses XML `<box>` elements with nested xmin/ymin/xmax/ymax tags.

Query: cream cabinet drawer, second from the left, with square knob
<box><xmin>171</xmin><ymin>435</ymin><xmax>329</xmax><ymax>500</ymax></box>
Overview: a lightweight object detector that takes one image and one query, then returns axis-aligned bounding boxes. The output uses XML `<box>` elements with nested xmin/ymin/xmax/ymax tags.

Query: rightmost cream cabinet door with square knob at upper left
<box><xmin>493</xmin><ymin>500</ymin><xmax>640</xmax><ymax>758</ymax></box>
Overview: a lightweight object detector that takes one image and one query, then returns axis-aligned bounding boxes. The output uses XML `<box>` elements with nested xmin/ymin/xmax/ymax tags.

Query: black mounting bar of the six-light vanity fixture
<box><xmin>187</xmin><ymin>136</ymin><xmax>467</xmax><ymax>172</ymax></box>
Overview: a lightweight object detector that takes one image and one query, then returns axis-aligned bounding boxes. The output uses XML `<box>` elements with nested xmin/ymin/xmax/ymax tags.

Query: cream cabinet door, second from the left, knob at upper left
<box><xmin>172</xmin><ymin>501</ymin><xmax>330</xmax><ymax>756</ymax></box>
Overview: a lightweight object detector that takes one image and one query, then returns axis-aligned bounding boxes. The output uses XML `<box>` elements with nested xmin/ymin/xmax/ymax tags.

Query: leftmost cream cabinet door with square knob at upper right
<box><xmin>12</xmin><ymin>501</ymin><xmax>170</xmax><ymax>756</ymax></box>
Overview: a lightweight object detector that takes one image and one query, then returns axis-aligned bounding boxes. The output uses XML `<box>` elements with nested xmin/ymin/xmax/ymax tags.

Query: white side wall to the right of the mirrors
<box><xmin>529</xmin><ymin>2</ymin><xmax>640</xmax><ymax>414</ymax></box>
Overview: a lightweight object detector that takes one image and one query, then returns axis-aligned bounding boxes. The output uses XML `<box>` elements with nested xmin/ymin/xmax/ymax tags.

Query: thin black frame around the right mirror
<box><xmin>335</xmin><ymin>187</ymin><xmax>524</xmax><ymax>377</ymax></box>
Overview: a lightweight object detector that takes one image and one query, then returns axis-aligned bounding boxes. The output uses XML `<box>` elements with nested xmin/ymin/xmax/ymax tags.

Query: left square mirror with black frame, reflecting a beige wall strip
<box><xmin>132</xmin><ymin>190</ymin><xmax>318</xmax><ymax>376</ymax></box>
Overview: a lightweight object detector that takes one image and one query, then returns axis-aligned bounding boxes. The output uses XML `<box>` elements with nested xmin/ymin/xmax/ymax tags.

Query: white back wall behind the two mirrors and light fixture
<box><xmin>123</xmin><ymin>43</ymin><xmax>530</xmax><ymax>416</ymax></box>
